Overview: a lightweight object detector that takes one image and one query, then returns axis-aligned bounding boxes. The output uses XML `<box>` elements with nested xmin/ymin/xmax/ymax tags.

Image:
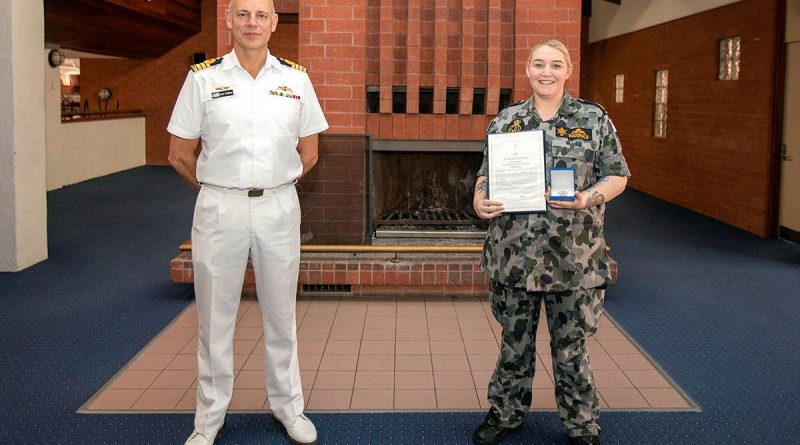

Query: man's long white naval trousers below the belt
<box><xmin>192</xmin><ymin>184</ymin><xmax>303</xmax><ymax>437</ymax></box>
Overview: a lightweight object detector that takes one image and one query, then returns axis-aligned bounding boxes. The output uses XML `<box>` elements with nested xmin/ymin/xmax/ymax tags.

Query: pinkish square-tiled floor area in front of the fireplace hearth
<box><xmin>81</xmin><ymin>297</ymin><xmax>696</xmax><ymax>412</ymax></box>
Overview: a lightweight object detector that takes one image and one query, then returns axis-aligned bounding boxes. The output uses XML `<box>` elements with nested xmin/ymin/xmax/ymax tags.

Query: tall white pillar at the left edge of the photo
<box><xmin>0</xmin><ymin>0</ymin><xmax>47</xmax><ymax>271</ymax></box>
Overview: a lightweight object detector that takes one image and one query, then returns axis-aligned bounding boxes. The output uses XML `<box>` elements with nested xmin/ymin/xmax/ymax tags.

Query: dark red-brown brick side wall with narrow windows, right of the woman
<box><xmin>583</xmin><ymin>0</ymin><xmax>781</xmax><ymax>236</ymax></box>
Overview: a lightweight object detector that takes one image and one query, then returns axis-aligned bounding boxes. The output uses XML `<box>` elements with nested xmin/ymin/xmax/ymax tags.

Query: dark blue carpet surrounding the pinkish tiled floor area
<box><xmin>0</xmin><ymin>167</ymin><xmax>800</xmax><ymax>445</ymax></box>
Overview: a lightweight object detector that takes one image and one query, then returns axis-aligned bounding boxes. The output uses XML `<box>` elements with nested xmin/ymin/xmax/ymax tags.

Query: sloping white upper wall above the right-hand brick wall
<box><xmin>589</xmin><ymin>0</ymin><xmax>744</xmax><ymax>43</ymax></box>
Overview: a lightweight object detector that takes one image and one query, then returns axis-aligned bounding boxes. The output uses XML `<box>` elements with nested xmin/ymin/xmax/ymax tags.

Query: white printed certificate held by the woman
<box><xmin>488</xmin><ymin>130</ymin><xmax>547</xmax><ymax>212</ymax></box>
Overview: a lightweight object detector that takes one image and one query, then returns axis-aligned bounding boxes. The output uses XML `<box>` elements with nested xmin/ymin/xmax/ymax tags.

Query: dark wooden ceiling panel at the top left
<box><xmin>44</xmin><ymin>0</ymin><xmax>200</xmax><ymax>59</ymax></box>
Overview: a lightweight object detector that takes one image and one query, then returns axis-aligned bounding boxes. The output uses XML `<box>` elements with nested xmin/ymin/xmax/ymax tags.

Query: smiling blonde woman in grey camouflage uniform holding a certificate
<box><xmin>473</xmin><ymin>40</ymin><xmax>630</xmax><ymax>445</ymax></box>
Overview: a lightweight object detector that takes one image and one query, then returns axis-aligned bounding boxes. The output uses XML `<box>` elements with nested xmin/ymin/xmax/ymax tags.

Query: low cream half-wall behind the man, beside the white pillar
<box><xmin>45</xmin><ymin>61</ymin><xmax>145</xmax><ymax>190</ymax></box>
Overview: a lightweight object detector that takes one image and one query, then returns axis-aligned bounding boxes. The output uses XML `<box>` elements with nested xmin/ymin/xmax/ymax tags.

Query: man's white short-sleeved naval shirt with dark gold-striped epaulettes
<box><xmin>167</xmin><ymin>51</ymin><xmax>328</xmax><ymax>189</ymax></box>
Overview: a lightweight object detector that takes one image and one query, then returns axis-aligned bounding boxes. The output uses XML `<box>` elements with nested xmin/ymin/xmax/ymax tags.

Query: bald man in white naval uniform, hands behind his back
<box><xmin>167</xmin><ymin>0</ymin><xmax>328</xmax><ymax>445</ymax></box>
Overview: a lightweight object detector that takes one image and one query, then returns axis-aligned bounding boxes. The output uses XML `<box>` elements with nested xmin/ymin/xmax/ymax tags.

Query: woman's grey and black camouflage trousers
<box><xmin>489</xmin><ymin>281</ymin><xmax>605</xmax><ymax>437</ymax></box>
